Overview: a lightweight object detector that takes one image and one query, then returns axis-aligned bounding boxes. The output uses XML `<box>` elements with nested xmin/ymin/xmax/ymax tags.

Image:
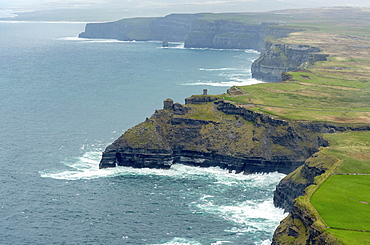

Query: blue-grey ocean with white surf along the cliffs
<box><xmin>0</xmin><ymin>22</ymin><xmax>286</xmax><ymax>245</ymax></box>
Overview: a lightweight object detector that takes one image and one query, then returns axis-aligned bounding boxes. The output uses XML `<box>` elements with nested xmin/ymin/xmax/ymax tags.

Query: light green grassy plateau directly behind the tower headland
<box><xmin>224</xmin><ymin>68</ymin><xmax>370</xmax><ymax>123</ymax></box>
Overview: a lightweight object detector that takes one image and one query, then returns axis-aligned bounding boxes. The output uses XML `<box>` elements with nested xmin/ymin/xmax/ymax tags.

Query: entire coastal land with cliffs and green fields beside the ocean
<box><xmin>80</xmin><ymin>7</ymin><xmax>370</xmax><ymax>245</ymax></box>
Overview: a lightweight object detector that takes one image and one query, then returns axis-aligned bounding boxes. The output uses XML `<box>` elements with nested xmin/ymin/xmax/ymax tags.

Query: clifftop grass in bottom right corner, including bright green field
<box><xmin>311</xmin><ymin>132</ymin><xmax>370</xmax><ymax>244</ymax></box>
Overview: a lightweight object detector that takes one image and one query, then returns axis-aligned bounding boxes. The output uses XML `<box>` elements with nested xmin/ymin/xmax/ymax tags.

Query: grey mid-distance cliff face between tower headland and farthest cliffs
<box><xmin>252</xmin><ymin>43</ymin><xmax>327</xmax><ymax>82</ymax></box>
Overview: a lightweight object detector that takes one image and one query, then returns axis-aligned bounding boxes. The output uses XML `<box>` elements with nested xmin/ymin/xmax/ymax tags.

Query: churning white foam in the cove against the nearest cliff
<box><xmin>194</xmin><ymin>172</ymin><xmax>287</xmax><ymax>244</ymax></box>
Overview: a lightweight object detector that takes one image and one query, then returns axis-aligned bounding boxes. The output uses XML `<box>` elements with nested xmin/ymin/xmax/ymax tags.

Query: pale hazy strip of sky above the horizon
<box><xmin>0</xmin><ymin>0</ymin><xmax>370</xmax><ymax>18</ymax></box>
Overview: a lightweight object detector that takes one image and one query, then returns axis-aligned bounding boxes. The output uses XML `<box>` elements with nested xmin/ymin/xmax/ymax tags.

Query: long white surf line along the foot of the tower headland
<box><xmin>40</xmin><ymin>151</ymin><xmax>284</xmax><ymax>184</ymax></box>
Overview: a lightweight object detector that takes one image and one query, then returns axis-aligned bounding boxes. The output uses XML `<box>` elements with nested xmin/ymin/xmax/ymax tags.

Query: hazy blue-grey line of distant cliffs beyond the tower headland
<box><xmin>79</xmin><ymin>14</ymin><xmax>310</xmax><ymax>82</ymax></box>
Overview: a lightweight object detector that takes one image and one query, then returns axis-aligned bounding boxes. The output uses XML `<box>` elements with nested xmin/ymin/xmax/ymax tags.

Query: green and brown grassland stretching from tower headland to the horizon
<box><xmin>225</xmin><ymin>8</ymin><xmax>370</xmax><ymax>123</ymax></box>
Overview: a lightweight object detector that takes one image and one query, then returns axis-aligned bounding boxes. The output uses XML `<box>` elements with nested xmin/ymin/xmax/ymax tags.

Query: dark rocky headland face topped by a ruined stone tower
<box><xmin>100</xmin><ymin>96</ymin><xmax>327</xmax><ymax>173</ymax></box>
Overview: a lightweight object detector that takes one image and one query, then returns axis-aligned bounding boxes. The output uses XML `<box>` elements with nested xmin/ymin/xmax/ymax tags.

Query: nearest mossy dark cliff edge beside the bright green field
<box><xmin>272</xmin><ymin>151</ymin><xmax>340</xmax><ymax>245</ymax></box>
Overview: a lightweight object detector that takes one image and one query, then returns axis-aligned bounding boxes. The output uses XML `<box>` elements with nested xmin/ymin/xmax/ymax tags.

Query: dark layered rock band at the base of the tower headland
<box><xmin>99</xmin><ymin>149</ymin><xmax>302</xmax><ymax>174</ymax></box>
